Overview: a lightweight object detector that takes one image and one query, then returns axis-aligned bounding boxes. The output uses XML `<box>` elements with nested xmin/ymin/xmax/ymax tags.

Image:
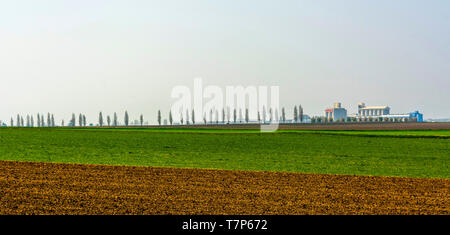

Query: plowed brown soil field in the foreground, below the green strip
<box><xmin>0</xmin><ymin>161</ymin><xmax>450</xmax><ymax>215</ymax></box>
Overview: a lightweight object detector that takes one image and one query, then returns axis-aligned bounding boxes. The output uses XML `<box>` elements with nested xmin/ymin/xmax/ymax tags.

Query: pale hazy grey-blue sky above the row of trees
<box><xmin>0</xmin><ymin>0</ymin><xmax>450</xmax><ymax>123</ymax></box>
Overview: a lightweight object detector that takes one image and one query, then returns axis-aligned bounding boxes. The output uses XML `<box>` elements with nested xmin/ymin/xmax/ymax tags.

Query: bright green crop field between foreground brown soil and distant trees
<box><xmin>0</xmin><ymin>128</ymin><xmax>450</xmax><ymax>178</ymax></box>
